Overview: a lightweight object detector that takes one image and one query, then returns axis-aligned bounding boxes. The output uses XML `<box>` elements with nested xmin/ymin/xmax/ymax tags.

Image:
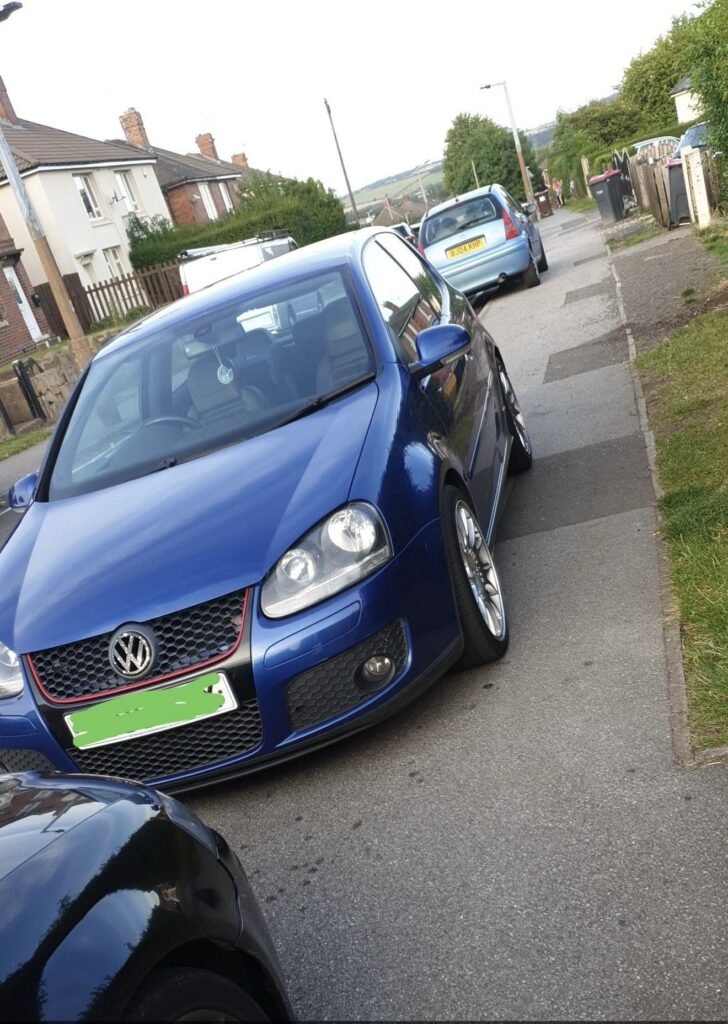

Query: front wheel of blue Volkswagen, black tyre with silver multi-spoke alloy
<box><xmin>442</xmin><ymin>485</ymin><xmax>508</xmax><ymax>669</ymax></box>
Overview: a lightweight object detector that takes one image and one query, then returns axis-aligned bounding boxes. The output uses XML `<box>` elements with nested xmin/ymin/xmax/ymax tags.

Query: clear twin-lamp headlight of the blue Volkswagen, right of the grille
<box><xmin>261</xmin><ymin>502</ymin><xmax>392</xmax><ymax>618</ymax></box>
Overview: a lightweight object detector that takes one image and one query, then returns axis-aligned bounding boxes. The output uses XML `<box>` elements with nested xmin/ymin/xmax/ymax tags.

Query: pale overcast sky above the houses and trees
<box><xmin>0</xmin><ymin>0</ymin><xmax>696</xmax><ymax>195</ymax></box>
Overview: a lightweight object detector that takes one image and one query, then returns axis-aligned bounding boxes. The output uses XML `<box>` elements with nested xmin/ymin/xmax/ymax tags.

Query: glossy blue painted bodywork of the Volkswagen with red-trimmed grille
<box><xmin>0</xmin><ymin>229</ymin><xmax>511</xmax><ymax>785</ymax></box>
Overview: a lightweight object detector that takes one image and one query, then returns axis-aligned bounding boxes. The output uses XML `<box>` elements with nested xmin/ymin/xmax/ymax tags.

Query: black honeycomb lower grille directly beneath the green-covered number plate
<box><xmin>67</xmin><ymin>700</ymin><xmax>263</xmax><ymax>782</ymax></box>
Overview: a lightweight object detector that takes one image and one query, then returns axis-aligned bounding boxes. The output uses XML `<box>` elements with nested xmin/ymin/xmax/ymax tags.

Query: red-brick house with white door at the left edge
<box><xmin>0</xmin><ymin>208</ymin><xmax>49</xmax><ymax>364</ymax></box>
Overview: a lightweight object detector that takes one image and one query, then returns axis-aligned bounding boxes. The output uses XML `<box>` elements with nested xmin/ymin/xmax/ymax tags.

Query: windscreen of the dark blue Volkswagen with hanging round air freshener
<box><xmin>49</xmin><ymin>270</ymin><xmax>375</xmax><ymax>501</ymax></box>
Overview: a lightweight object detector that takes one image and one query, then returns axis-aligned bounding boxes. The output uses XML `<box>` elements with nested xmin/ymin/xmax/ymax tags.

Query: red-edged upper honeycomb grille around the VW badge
<box><xmin>29</xmin><ymin>591</ymin><xmax>245</xmax><ymax>700</ymax></box>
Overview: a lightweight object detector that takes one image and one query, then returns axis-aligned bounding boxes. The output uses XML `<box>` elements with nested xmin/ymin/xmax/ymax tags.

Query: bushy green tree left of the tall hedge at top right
<box><xmin>622</xmin><ymin>14</ymin><xmax>695</xmax><ymax>132</ymax></box>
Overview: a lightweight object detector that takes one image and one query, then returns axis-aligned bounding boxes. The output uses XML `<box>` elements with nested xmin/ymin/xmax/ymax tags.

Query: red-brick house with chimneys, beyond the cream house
<box><xmin>119</xmin><ymin>106</ymin><xmax>253</xmax><ymax>224</ymax></box>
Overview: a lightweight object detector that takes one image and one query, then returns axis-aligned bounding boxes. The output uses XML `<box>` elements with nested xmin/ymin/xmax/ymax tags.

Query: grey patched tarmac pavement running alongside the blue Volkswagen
<box><xmin>182</xmin><ymin>208</ymin><xmax>728</xmax><ymax>1020</ymax></box>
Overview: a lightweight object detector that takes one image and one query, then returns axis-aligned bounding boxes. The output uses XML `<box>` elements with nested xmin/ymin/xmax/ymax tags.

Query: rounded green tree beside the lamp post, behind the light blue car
<box><xmin>442</xmin><ymin>114</ymin><xmax>536</xmax><ymax>200</ymax></box>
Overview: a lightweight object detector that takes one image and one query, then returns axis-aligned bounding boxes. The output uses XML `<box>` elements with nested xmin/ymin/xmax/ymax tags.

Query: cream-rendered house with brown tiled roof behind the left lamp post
<box><xmin>0</xmin><ymin>79</ymin><xmax>167</xmax><ymax>286</ymax></box>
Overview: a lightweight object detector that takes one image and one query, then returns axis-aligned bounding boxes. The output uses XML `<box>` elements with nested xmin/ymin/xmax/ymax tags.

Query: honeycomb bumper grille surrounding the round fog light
<box><xmin>287</xmin><ymin>622</ymin><xmax>406</xmax><ymax>729</ymax></box>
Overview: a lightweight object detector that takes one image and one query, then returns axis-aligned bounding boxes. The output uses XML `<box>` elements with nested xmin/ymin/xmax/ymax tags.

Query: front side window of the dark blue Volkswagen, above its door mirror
<box><xmin>363</xmin><ymin>237</ymin><xmax>439</xmax><ymax>366</ymax></box>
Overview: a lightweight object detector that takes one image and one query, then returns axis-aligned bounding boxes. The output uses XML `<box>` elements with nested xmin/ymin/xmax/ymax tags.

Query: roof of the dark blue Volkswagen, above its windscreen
<box><xmin>98</xmin><ymin>227</ymin><xmax>391</xmax><ymax>362</ymax></box>
